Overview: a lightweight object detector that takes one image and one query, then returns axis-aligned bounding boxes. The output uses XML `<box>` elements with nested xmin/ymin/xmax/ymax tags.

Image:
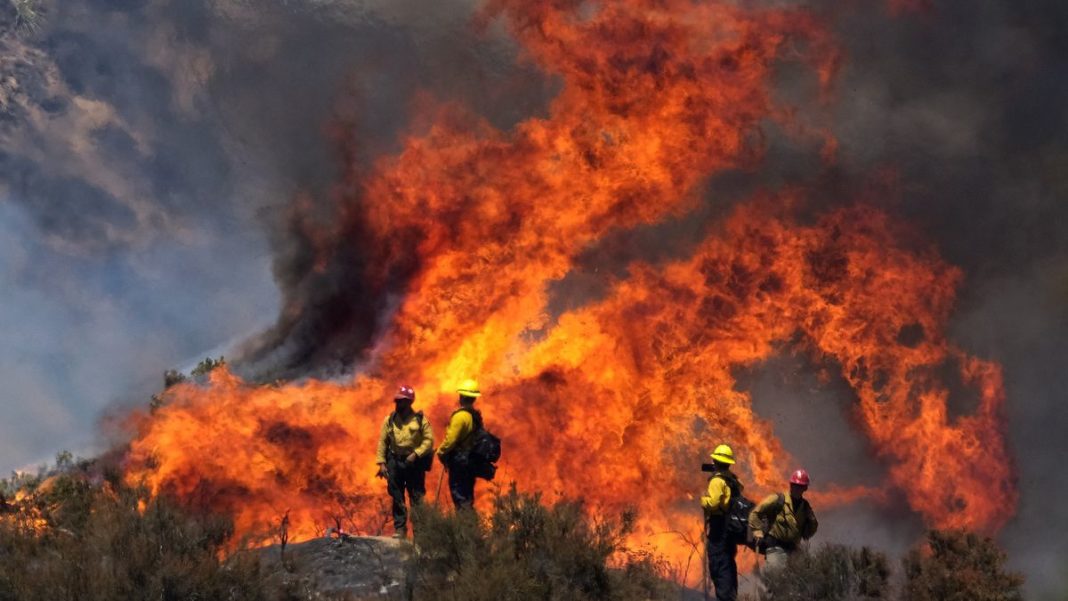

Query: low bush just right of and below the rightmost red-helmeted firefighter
<box><xmin>758</xmin><ymin>544</ymin><xmax>891</xmax><ymax>601</ymax></box>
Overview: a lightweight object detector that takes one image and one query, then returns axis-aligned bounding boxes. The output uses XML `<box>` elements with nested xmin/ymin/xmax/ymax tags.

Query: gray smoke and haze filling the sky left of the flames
<box><xmin>0</xmin><ymin>0</ymin><xmax>548</xmax><ymax>459</ymax></box>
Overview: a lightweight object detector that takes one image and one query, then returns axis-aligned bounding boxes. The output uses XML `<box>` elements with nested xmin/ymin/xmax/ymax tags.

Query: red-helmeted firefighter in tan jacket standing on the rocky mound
<box><xmin>375</xmin><ymin>385</ymin><xmax>434</xmax><ymax>538</ymax></box>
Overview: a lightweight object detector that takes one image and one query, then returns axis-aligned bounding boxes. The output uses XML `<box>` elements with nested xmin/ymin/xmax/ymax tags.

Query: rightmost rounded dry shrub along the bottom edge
<box><xmin>902</xmin><ymin>531</ymin><xmax>1023</xmax><ymax>601</ymax></box>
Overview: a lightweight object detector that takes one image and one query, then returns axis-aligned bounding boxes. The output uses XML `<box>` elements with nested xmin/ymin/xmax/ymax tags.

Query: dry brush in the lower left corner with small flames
<box><xmin>0</xmin><ymin>465</ymin><xmax>279</xmax><ymax>601</ymax></box>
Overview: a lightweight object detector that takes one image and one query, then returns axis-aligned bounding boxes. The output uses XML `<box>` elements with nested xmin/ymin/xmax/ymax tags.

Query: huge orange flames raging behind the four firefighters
<box><xmin>121</xmin><ymin>0</ymin><xmax>1017</xmax><ymax>576</ymax></box>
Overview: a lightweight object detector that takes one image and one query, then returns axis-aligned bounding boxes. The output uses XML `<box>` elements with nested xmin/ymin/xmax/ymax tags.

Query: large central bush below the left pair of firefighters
<box><xmin>408</xmin><ymin>487</ymin><xmax>676</xmax><ymax>601</ymax></box>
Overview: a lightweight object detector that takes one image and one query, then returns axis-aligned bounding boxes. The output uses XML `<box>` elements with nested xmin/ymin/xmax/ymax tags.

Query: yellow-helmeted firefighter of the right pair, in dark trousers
<box><xmin>701</xmin><ymin>444</ymin><xmax>743</xmax><ymax>601</ymax></box>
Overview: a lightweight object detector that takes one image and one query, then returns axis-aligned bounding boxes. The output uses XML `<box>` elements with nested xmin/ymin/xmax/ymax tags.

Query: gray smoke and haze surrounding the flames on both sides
<box><xmin>0</xmin><ymin>0</ymin><xmax>1068</xmax><ymax>598</ymax></box>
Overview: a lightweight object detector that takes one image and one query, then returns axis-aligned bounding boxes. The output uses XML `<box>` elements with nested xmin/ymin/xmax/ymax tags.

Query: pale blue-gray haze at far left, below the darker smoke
<box><xmin>0</xmin><ymin>192</ymin><xmax>278</xmax><ymax>470</ymax></box>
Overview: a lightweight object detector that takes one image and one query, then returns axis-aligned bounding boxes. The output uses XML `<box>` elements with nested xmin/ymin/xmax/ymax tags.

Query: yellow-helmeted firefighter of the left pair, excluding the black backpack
<box><xmin>438</xmin><ymin>380</ymin><xmax>483</xmax><ymax>509</ymax></box>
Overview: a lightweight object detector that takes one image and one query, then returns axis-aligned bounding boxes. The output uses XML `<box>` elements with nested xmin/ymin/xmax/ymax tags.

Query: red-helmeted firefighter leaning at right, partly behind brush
<box><xmin>749</xmin><ymin>470</ymin><xmax>819</xmax><ymax>570</ymax></box>
